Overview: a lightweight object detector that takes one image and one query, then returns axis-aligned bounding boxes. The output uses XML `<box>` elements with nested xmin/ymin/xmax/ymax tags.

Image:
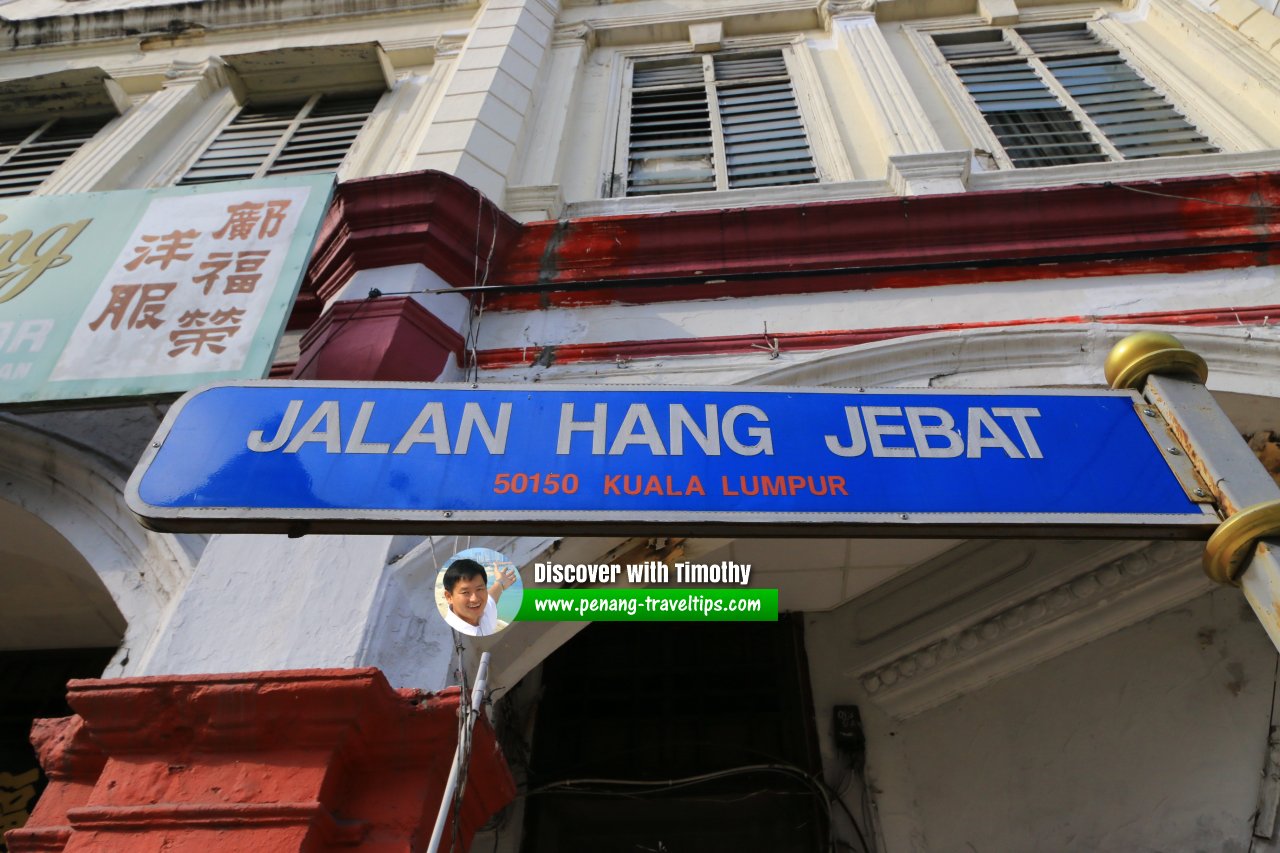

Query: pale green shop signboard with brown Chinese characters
<box><xmin>0</xmin><ymin>175</ymin><xmax>333</xmax><ymax>405</ymax></box>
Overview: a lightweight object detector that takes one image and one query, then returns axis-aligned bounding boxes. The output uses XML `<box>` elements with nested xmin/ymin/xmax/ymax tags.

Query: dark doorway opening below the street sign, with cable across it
<box><xmin>522</xmin><ymin>617</ymin><xmax>827</xmax><ymax>853</ymax></box>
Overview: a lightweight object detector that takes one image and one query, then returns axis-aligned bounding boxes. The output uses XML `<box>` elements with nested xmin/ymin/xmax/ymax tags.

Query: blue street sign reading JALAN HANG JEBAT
<box><xmin>128</xmin><ymin>382</ymin><xmax>1217</xmax><ymax>538</ymax></box>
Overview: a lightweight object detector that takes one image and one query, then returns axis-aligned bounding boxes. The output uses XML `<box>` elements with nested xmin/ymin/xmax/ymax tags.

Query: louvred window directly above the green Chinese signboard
<box><xmin>178</xmin><ymin>92</ymin><xmax>381</xmax><ymax>184</ymax></box>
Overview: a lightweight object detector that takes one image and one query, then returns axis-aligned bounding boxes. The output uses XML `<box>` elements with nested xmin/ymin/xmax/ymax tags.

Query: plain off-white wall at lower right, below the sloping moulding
<box><xmin>834</xmin><ymin>589</ymin><xmax>1276</xmax><ymax>853</ymax></box>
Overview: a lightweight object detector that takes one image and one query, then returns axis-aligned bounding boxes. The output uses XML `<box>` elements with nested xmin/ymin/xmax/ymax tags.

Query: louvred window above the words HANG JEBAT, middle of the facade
<box><xmin>613</xmin><ymin>49</ymin><xmax>818</xmax><ymax>196</ymax></box>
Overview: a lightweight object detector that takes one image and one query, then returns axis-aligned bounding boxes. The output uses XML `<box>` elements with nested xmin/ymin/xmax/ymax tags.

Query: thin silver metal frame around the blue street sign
<box><xmin>125</xmin><ymin>382</ymin><xmax>1219</xmax><ymax>539</ymax></box>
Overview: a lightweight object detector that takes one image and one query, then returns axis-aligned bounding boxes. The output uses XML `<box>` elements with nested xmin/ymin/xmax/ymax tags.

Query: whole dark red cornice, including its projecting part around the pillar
<box><xmin>294</xmin><ymin>166</ymin><xmax>1280</xmax><ymax>310</ymax></box>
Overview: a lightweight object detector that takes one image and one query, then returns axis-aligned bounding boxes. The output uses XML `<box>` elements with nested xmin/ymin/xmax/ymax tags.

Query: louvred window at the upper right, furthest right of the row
<box><xmin>933</xmin><ymin>23</ymin><xmax>1217</xmax><ymax>167</ymax></box>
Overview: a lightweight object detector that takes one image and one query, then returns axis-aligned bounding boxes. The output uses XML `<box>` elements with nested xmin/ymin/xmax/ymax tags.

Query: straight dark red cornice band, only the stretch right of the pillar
<box><xmin>490</xmin><ymin>167</ymin><xmax>1280</xmax><ymax>307</ymax></box>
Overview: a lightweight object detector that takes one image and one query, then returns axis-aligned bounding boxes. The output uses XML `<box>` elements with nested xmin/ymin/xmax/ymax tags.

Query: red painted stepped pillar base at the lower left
<box><xmin>6</xmin><ymin>669</ymin><xmax>515</xmax><ymax>853</ymax></box>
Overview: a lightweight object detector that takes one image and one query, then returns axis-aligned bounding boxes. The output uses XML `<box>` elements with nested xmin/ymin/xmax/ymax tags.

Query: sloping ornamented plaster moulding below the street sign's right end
<box><xmin>851</xmin><ymin>542</ymin><xmax>1210</xmax><ymax>719</ymax></box>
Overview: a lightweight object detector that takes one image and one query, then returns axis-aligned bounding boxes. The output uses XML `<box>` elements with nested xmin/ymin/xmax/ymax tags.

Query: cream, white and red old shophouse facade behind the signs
<box><xmin>0</xmin><ymin>0</ymin><xmax>1280</xmax><ymax>853</ymax></box>
